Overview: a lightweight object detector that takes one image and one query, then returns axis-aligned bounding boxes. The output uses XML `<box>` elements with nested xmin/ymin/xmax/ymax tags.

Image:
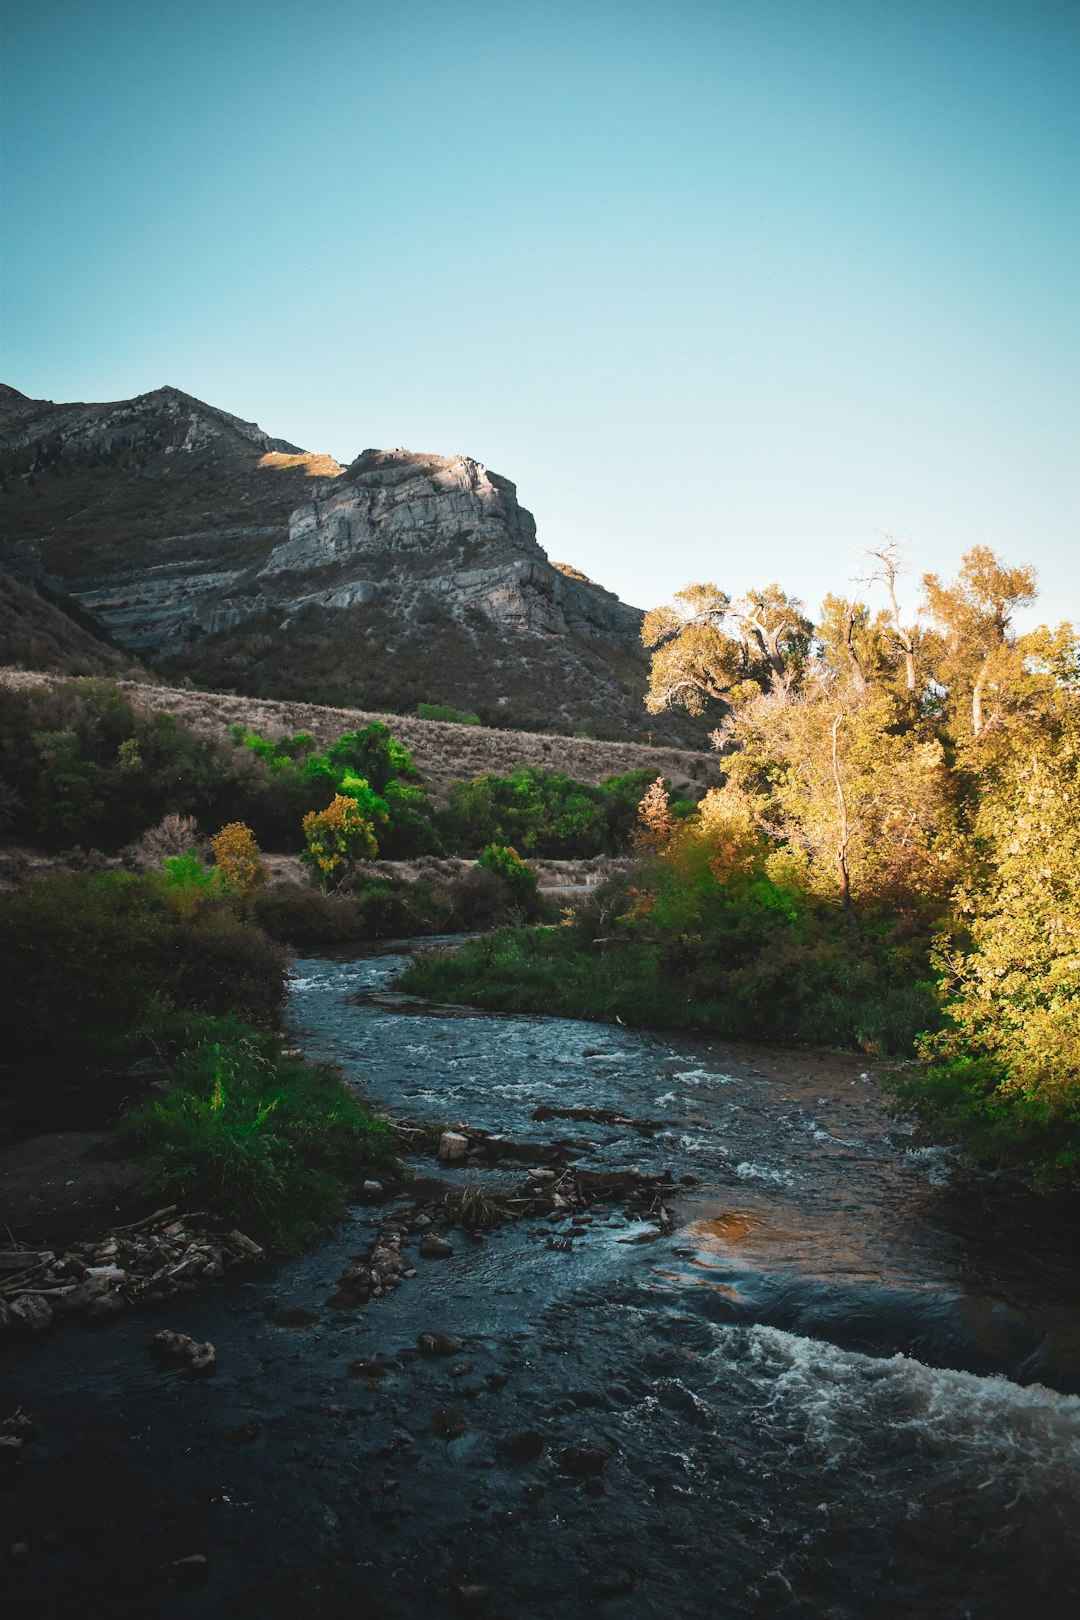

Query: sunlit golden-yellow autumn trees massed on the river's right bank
<box><xmin>628</xmin><ymin>536</ymin><xmax>1080</xmax><ymax>1186</ymax></box>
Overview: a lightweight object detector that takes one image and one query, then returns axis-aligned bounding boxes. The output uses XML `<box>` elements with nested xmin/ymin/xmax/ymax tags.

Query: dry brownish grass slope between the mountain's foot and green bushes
<box><xmin>0</xmin><ymin>669</ymin><xmax>719</xmax><ymax>791</ymax></box>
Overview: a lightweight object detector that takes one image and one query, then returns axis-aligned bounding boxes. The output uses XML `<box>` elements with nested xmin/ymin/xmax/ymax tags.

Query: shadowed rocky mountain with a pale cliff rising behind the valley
<box><xmin>0</xmin><ymin>387</ymin><xmax>698</xmax><ymax>740</ymax></box>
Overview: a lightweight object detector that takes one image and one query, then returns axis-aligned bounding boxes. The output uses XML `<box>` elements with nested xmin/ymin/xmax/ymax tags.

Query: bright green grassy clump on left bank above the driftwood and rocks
<box><xmin>117</xmin><ymin>1019</ymin><xmax>397</xmax><ymax>1249</ymax></box>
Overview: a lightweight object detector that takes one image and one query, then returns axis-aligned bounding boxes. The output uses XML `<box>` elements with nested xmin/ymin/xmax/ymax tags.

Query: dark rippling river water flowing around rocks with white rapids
<box><xmin>0</xmin><ymin>949</ymin><xmax>1080</xmax><ymax>1620</ymax></box>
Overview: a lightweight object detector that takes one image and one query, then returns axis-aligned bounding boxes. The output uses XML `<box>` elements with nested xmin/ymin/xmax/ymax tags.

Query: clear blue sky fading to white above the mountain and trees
<box><xmin>2</xmin><ymin>0</ymin><xmax>1080</xmax><ymax>619</ymax></box>
